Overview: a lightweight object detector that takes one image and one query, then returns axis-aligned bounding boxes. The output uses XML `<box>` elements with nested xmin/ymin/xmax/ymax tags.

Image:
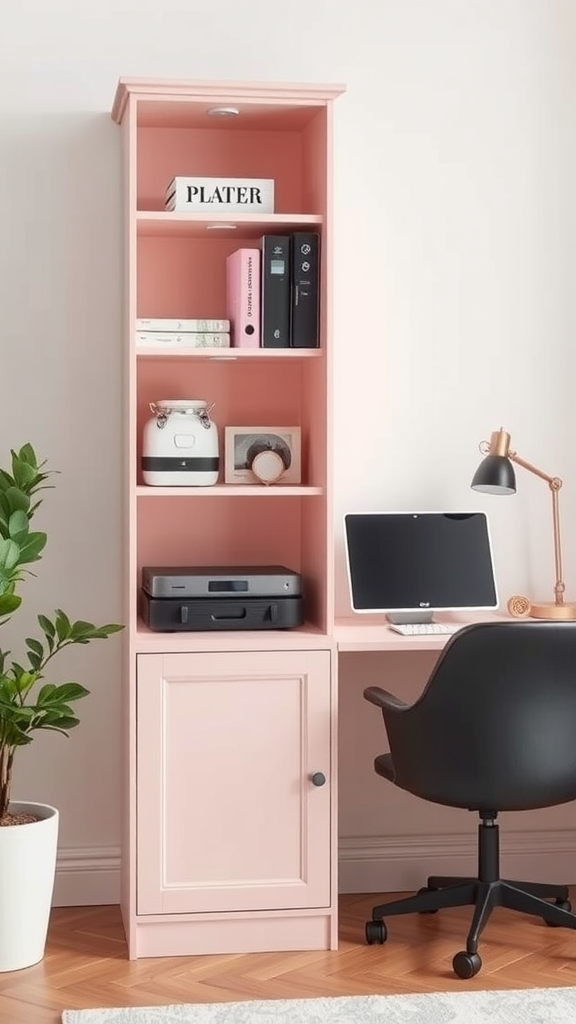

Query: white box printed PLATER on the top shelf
<box><xmin>165</xmin><ymin>178</ymin><xmax>274</xmax><ymax>213</ymax></box>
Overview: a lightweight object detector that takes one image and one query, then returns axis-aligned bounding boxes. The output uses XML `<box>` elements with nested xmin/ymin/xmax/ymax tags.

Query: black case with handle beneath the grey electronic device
<box><xmin>140</xmin><ymin>590</ymin><xmax>304</xmax><ymax>633</ymax></box>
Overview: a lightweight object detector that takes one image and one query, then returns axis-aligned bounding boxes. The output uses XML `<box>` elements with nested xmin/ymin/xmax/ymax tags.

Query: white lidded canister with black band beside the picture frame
<box><xmin>141</xmin><ymin>398</ymin><xmax>219</xmax><ymax>487</ymax></box>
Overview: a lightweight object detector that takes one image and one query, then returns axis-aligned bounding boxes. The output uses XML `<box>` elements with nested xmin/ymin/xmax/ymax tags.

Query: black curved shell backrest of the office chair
<box><xmin>383</xmin><ymin>621</ymin><xmax>576</xmax><ymax>811</ymax></box>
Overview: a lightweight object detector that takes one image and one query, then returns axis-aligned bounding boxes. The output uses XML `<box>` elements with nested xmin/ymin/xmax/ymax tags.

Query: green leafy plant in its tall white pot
<box><xmin>0</xmin><ymin>444</ymin><xmax>123</xmax><ymax>971</ymax></box>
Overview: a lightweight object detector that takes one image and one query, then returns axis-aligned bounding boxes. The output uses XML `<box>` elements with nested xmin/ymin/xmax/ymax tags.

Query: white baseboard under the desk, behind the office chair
<box><xmin>338</xmin><ymin>828</ymin><xmax>576</xmax><ymax>893</ymax></box>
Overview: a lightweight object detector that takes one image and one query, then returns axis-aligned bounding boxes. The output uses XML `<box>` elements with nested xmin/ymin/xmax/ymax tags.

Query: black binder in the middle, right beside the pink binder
<box><xmin>260</xmin><ymin>234</ymin><xmax>290</xmax><ymax>348</ymax></box>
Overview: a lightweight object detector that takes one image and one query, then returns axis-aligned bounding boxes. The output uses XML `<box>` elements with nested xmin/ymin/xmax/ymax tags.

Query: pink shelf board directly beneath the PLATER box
<box><xmin>136</xmin><ymin>210</ymin><xmax>324</xmax><ymax>239</ymax></box>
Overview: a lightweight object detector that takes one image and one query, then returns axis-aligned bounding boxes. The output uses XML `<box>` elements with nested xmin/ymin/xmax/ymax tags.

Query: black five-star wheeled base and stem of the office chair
<box><xmin>366</xmin><ymin>818</ymin><xmax>576</xmax><ymax>977</ymax></box>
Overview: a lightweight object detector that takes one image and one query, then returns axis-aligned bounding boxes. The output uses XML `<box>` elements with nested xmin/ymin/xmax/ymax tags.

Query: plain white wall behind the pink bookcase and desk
<box><xmin>0</xmin><ymin>0</ymin><xmax>576</xmax><ymax>902</ymax></box>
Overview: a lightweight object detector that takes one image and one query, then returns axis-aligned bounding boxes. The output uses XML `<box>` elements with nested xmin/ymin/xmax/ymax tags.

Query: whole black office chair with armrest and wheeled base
<box><xmin>364</xmin><ymin>621</ymin><xmax>576</xmax><ymax>978</ymax></box>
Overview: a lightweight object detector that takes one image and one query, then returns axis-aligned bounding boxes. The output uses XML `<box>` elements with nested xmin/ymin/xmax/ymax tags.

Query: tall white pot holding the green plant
<box><xmin>0</xmin><ymin>802</ymin><xmax>58</xmax><ymax>971</ymax></box>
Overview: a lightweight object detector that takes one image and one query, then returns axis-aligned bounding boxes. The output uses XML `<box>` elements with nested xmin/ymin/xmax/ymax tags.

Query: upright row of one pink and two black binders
<box><xmin>227</xmin><ymin>231</ymin><xmax>320</xmax><ymax>348</ymax></box>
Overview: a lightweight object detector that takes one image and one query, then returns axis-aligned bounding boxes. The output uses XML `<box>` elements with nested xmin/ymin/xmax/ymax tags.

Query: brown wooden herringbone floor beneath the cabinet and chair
<box><xmin>0</xmin><ymin>892</ymin><xmax>576</xmax><ymax>1024</ymax></box>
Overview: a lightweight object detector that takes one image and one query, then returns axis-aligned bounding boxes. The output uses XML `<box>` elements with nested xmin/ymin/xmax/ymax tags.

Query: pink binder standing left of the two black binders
<box><xmin>227</xmin><ymin>249</ymin><xmax>260</xmax><ymax>348</ymax></box>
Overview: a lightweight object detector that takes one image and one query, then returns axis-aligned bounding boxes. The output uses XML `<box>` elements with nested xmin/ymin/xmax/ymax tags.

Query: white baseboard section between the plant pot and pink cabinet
<box><xmin>52</xmin><ymin>846</ymin><xmax>120</xmax><ymax>906</ymax></box>
